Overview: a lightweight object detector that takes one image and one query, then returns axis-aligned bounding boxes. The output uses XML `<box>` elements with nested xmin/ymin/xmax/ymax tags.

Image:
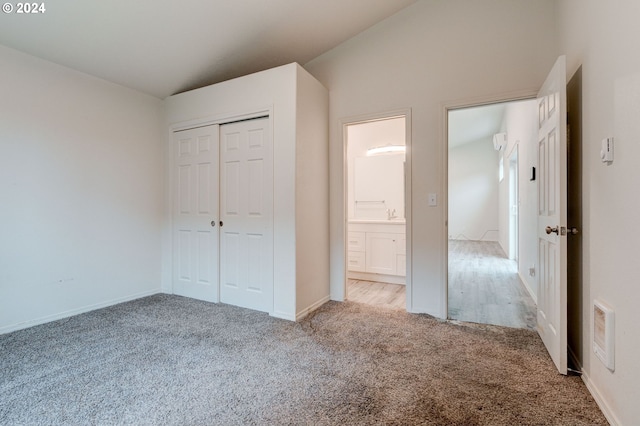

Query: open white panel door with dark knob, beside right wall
<box><xmin>538</xmin><ymin>56</ymin><xmax>567</xmax><ymax>374</ymax></box>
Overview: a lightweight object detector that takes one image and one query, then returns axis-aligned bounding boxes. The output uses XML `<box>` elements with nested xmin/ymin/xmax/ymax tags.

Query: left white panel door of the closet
<box><xmin>173</xmin><ymin>124</ymin><xmax>219</xmax><ymax>302</ymax></box>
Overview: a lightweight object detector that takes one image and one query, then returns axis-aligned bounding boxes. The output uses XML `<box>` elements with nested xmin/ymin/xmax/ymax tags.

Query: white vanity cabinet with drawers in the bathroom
<box><xmin>347</xmin><ymin>221</ymin><xmax>406</xmax><ymax>284</ymax></box>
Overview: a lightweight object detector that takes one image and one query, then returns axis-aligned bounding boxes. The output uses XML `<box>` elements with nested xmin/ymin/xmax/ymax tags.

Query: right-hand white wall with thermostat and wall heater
<box><xmin>557</xmin><ymin>0</ymin><xmax>640</xmax><ymax>425</ymax></box>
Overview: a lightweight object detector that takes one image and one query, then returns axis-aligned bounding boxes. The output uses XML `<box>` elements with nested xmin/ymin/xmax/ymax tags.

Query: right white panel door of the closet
<box><xmin>220</xmin><ymin>118</ymin><xmax>274</xmax><ymax>312</ymax></box>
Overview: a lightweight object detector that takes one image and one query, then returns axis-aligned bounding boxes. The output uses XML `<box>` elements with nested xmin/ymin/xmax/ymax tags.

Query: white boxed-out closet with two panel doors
<box><xmin>165</xmin><ymin>64</ymin><xmax>329</xmax><ymax>321</ymax></box>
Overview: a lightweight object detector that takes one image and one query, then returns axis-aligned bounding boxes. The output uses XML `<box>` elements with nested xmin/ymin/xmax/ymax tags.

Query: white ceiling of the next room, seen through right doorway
<box><xmin>449</xmin><ymin>103</ymin><xmax>508</xmax><ymax>149</ymax></box>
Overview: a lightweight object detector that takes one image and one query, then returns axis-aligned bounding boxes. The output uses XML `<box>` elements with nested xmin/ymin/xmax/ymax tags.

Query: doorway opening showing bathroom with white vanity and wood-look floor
<box><xmin>344</xmin><ymin>115</ymin><xmax>410</xmax><ymax>309</ymax></box>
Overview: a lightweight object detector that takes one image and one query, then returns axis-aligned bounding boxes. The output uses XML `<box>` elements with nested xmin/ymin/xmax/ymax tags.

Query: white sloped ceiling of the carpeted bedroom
<box><xmin>0</xmin><ymin>0</ymin><xmax>416</xmax><ymax>98</ymax></box>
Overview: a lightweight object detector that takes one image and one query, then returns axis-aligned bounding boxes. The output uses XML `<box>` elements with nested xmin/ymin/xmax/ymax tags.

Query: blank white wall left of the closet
<box><xmin>0</xmin><ymin>46</ymin><xmax>163</xmax><ymax>333</ymax></box>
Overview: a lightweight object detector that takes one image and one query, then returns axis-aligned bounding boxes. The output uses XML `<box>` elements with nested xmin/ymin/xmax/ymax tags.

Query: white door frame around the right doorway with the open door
<box><xmin>440</xmin><ymin>90</ymin><xmax>538</xmax><ymax>319</ymax></box>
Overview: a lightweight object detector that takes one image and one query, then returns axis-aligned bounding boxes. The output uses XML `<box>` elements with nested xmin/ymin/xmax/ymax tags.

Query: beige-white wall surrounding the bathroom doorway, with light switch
<box><xmin>305</xmin><ymin>0</ymin><xmax>557</xmax><ymax>317</ymax></box>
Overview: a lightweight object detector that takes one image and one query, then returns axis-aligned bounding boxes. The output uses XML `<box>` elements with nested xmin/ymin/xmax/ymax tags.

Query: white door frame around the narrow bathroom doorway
<box><xmin>334</xmin><ymin>108</ymin><xmax>413</xmax><ymax>312</ymax></box>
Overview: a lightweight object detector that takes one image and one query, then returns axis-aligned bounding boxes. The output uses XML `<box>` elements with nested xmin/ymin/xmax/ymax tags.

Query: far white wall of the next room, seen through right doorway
<box><xmin>448</xmin><ymin>138</ymin><xmax>499</xmax><ymax>241</ymax></box>
